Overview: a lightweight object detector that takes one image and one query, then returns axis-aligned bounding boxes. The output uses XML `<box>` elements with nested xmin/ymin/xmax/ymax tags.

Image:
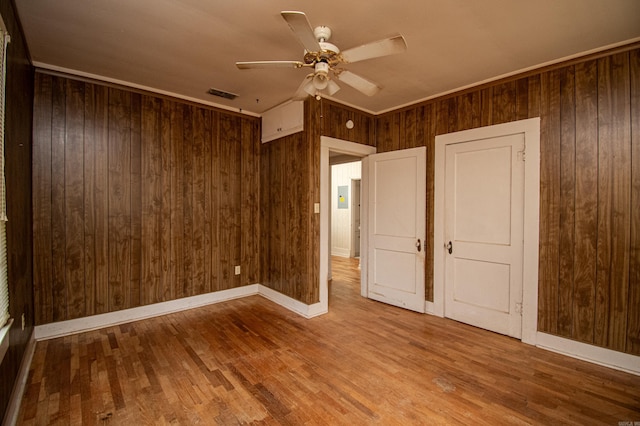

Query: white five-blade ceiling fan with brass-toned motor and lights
<box><xmin>236</xmin><ymin>11</ymin><xmax>407</xmax><ymax>99</ymax></box>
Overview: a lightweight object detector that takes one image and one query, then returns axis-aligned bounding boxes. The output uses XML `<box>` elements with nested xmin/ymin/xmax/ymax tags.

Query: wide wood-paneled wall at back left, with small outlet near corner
<box><xmin>33</xmin><ymin>72</ymin><xmax>260</xmax><ymax>324</ymax></box>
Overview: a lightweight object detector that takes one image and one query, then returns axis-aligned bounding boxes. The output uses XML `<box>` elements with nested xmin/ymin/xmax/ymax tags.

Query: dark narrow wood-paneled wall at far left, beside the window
<box><xmin>0</xmin><ymin>0</ymin><xmax>34</xmax><ymax>423</ymax></box>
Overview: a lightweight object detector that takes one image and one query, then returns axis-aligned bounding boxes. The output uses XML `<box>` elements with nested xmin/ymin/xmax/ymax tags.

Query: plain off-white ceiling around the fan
<box><xmin>16</xmin><ymin>0</ymin><xmax>640</xmax><ymax>114</ymax></box>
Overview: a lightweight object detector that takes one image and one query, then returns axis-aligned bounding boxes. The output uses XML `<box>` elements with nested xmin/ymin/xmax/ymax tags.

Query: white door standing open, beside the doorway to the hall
<box><xmin>366</xmin><ymin>147</ymin><xmax>426</xmax><ymax>312</ymax></box>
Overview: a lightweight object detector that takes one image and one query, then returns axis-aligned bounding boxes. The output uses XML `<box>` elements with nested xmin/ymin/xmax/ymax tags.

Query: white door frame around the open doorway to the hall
<box><xmin>318</xmin><ymin>136</ymin><xmax>376</xmax><ymax>312</ymax></box>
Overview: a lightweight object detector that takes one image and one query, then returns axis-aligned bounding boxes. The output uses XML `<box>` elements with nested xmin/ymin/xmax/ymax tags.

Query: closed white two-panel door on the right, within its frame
<box><xmin>444</xmin><ymin>133</ymin><xmax>524</xmax><ymax>338</ymax></box>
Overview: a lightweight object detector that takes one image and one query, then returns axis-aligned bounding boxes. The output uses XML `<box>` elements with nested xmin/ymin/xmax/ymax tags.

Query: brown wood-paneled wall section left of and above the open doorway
<box><xmin>261</xmin><ymin>97</ymin><xmax>375</xmax><ymax>304</ymax></box>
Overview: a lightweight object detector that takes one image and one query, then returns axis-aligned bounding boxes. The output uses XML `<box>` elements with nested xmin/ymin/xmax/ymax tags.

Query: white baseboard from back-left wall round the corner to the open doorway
<box><xmin>34</xmin><ymin>284</ymin><xmax>328</xmax><ymax>340</ymax></box>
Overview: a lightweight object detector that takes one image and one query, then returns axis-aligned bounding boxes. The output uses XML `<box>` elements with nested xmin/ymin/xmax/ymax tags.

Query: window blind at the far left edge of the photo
<box><xmin>0</xmin><ymin>25</ymin><xmax>10</xmax><ymax>327</ymax></box>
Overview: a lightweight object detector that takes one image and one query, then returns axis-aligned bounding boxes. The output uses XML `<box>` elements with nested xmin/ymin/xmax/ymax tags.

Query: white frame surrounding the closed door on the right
<box><xmin>426</xmin><ymin>117</ymin><xmax>540</xmax><ymax>345</ymax></box>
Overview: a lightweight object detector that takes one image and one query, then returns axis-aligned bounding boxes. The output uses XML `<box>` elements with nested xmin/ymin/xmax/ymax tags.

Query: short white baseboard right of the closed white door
<box><xmin>536</xmin><ymin>332</ymin><xmax>640</xmax><ymax>376</ymax></box>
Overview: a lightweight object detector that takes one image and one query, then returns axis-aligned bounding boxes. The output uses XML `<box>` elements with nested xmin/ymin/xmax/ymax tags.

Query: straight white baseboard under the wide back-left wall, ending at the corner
<box><xmin>35</xmin><ymin>284</ymin><xmax>259</xmax><ymax>340</ymax></box>
